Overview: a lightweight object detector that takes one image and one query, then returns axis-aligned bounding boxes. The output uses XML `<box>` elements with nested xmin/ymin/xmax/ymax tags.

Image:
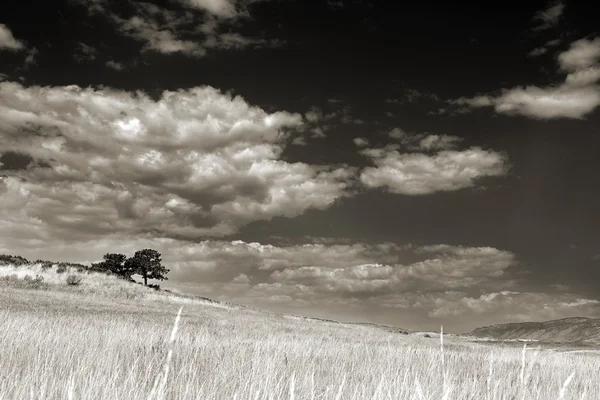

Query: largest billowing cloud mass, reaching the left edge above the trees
<box><xmin>0</xmin><ymin>81</ymin><xmax>355</xmax><ymax>238</ymax></box>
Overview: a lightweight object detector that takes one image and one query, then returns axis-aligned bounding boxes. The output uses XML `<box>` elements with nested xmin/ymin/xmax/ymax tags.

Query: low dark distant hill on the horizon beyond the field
<box><xmin>467</xmin><ymin>317</ymin><xmax>600</xmax><ymax>343</ymax></box>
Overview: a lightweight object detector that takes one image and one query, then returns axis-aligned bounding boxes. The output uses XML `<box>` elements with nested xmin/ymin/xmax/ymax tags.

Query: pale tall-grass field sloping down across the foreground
<box><xmin>0</xmin><ymin>266</ymin><xmax>600</xmax><ymax>400</ymax></box>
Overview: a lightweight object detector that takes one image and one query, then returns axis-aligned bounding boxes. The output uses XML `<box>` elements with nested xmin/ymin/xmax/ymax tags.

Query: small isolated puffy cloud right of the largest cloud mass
<box><xmin>360</xmin><ymin>128</ymin><xmax>508</xmax><ymax>195</ymax></box>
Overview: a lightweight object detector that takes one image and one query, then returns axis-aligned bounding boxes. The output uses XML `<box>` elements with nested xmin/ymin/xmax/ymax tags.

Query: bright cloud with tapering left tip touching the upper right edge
<box><xmin>452</xmin><ymin>38</ymin><xmax>600</xmax><ymax>119</ymax></box>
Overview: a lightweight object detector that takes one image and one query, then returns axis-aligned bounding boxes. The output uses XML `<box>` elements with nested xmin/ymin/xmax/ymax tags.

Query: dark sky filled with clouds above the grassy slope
<box><xmin>0</xmin><ymin>0</ymin><xmax>600</xmax><ymax>332</ymax></box>
